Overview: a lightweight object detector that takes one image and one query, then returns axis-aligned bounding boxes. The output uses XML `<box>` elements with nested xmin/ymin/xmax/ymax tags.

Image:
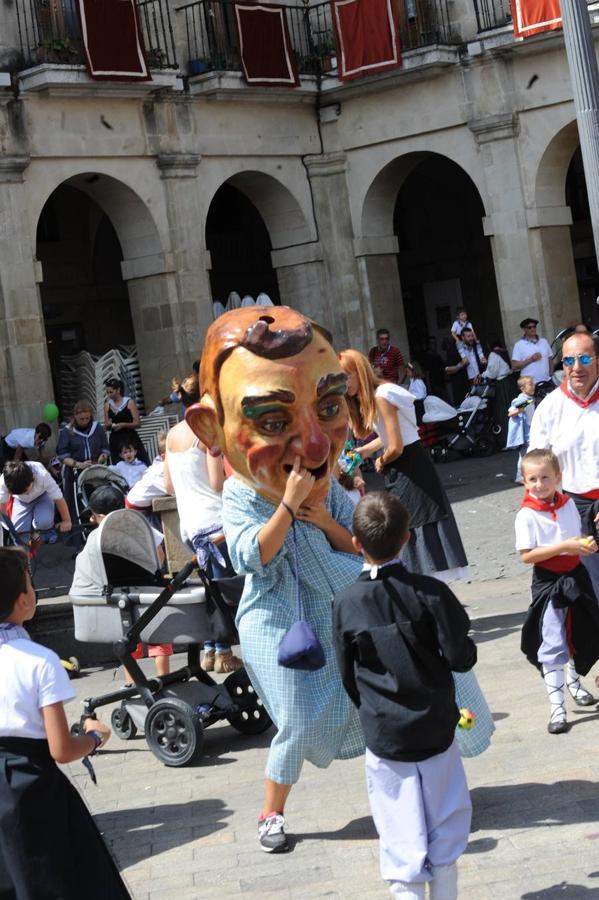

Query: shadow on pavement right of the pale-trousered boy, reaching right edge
<box><xmin>470</xmin><ymin>776</ymin><xmax>599</xmax><ymax>841</ymax></box>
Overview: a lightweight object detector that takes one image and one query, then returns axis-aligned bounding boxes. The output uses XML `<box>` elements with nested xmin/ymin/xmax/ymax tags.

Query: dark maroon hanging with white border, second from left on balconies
<box><xmin>234</xmin><ymin>3</ymin><xmax>299</xmax><ymax>87</ymax></box>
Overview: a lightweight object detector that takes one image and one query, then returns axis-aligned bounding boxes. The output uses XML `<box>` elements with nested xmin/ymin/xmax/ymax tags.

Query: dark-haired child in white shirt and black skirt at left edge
<box><xmin>0</xmin><ymin>547</ymin><xmax>131</xmax><ymax>900</ymax></box>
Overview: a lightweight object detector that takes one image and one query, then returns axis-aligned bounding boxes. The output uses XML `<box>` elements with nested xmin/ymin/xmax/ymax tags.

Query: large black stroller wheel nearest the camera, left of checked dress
<box><xmin>144</xmin><ymin>697</ymin><xmax>204</xmax><ymax>766</ymax></box>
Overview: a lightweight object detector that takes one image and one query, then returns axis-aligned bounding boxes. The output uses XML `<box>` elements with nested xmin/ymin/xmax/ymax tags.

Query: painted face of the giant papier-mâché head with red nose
<box><xmin>219</xmin><ymin>332</ymin><xmax>348</xmax><ymax>504</ymax></box>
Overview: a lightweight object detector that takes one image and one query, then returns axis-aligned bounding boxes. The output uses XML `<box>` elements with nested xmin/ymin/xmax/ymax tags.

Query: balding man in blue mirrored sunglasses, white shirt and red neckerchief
<box><xmin>529</xmin><ymin>334</ymin><xmax>599</xmax><ymax>597</ymax></box>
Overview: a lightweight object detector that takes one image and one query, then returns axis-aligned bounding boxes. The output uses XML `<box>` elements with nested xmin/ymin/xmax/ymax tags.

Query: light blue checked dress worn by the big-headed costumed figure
<box><xmin>223</xmin><ymin>477</ymin><xmax>364</xmax><ymax>784</ymax></box>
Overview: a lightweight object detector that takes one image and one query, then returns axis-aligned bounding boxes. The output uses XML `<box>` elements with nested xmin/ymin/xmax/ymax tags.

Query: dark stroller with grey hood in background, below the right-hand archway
<box><xmin>420</xmin><ymin>382</ymin><xmax>501</xmax><ymax>462</ymax></box>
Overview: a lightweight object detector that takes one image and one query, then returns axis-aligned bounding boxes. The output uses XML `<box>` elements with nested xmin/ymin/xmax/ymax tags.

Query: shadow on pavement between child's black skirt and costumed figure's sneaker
<box><xmin>94</xmin><ymin>800</ymin><xmax>233</xmax><ymax>869</ymax></box>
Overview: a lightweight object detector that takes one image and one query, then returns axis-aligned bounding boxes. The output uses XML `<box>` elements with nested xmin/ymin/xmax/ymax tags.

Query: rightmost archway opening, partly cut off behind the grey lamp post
<box><xmin>535</xmin><ymin>121</ymin><xmax>599</xmax><ymax>328</ymax></box>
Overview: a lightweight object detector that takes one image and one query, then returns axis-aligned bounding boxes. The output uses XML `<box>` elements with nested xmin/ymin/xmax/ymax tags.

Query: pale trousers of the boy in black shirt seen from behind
<box><xmin>366</xmin><ymin>741</ymin><xmax>472</xmax><ymax>883</ymax></box>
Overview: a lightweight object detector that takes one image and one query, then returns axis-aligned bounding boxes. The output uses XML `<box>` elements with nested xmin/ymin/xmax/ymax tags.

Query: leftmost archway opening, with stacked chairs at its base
<box><xmin>36</xmin><ymin>172</ymin><xmax>172</xmax><ymax>414</ymax></box>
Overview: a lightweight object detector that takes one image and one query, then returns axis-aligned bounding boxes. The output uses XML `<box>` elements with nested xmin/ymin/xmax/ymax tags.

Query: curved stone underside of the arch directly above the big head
<box><xmin>206</xmin><ymin>170</ymin><xmax>313</xmax><ymax>250</ymax></box>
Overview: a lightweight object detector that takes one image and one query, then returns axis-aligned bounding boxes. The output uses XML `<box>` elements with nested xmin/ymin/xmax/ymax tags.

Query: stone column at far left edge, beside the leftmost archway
<box><xmin>0</xmin><ymin>155</ymin><xmax>54</xmax><ymax>434</ymax></box>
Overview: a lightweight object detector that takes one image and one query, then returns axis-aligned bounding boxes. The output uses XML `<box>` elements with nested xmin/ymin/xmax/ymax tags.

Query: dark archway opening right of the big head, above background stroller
<box><xmin>362</xmin><ymin>152</ymin><xmax>502</xmax><ymax>354</ymax></box>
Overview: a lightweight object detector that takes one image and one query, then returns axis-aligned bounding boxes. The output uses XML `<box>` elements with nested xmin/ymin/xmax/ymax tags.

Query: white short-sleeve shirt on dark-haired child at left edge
<box><xmin>0</xmin><ymin>638</ymin><xmax>75</xmax><ymax>739</ymax></box>
